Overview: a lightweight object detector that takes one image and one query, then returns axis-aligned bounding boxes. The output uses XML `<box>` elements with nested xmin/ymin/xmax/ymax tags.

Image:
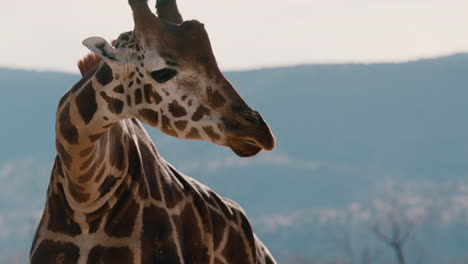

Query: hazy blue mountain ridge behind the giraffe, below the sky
<box><xmin>0</xmin><ymin>54</ymin><xmax>468</xmax><ymax>263</ymax></box>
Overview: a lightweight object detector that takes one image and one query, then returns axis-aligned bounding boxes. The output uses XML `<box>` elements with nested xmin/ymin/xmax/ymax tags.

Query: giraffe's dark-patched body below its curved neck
<box><xmin>31</xmin><ymin>119</ymin><xmax>275</xmax><ymax>264</ymax></box>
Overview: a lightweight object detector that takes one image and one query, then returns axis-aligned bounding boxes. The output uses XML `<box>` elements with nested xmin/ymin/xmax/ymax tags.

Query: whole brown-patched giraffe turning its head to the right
<box><xmin>30</xmin><ymin>0</ymin><xmax>276</xmax><ymax>264</ymax></box>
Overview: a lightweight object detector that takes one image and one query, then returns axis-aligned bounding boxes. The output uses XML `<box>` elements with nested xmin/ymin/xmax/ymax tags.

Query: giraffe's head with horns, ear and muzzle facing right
<box><xmin>83</xmin><ymin>0</ymin><xmax>275</xmax><ymax>157</ymax></box>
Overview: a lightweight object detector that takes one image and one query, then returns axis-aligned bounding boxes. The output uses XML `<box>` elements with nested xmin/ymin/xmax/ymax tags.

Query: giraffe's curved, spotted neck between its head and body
<box><xmin>56</xmin><ymin>62</ymin><xmax>144</xmax><ymax>211</ymax></box>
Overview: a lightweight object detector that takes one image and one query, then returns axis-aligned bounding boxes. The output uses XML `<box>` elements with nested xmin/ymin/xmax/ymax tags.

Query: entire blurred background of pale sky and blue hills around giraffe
<box><xmin>0</xmin><ymin>0</ymin><xmax>468</xmax><ymax>264</ymax></box>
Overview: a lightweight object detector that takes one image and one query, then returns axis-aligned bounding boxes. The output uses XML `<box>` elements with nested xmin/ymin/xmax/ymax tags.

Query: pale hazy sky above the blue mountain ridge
<box><xmin>0</xmin><ymin>0</ymin><xmax>468</xmax><ymax>72</ymax></box>
